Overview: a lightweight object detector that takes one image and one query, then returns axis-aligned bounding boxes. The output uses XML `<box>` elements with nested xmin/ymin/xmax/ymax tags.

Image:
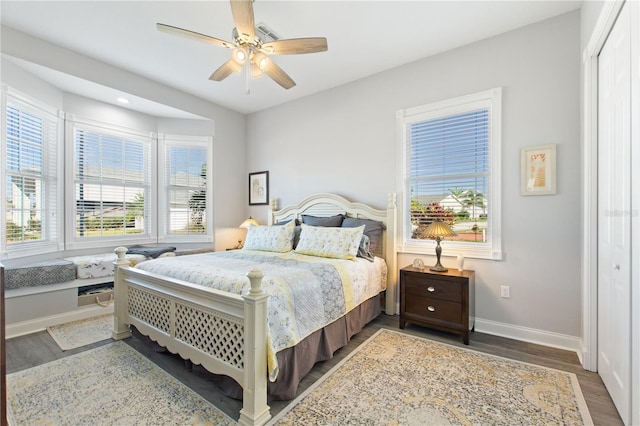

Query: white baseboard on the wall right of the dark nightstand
<box><xmin>476</xmin><ymin>318</ymin><xmax>582</xmax><ymax>358</ymax></box>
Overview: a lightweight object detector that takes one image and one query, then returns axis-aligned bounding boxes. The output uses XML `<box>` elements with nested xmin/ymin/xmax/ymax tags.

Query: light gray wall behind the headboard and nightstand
<box><xmin>247</xmin><ymin>11</ymin><xmax>581</xmax><ymax>339</ymax></box>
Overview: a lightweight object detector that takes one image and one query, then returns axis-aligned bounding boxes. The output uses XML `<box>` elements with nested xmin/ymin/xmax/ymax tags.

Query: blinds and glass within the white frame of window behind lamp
<box><xmin>407</xmin><ymin>108</ymin><xmax>490</xmax><ymax>242</ymax></box>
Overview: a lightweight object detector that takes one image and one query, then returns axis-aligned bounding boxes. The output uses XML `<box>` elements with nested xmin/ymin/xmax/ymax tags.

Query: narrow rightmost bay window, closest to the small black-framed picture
<box><xmin>158</xmin><ymin>135</ymin><xmax>213</xmax><ymax>242</ymax></box>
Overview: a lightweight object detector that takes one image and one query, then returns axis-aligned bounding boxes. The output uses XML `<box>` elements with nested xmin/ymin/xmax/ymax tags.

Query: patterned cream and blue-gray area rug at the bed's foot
<box><xmin>7</xmin><ymin>342</ymin><xmax>236</xmax><ymax>425</ymax></box>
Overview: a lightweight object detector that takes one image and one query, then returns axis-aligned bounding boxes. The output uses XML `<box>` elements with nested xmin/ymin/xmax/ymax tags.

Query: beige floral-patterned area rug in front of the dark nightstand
<box><xmin>271</xmin><ymin>330</ymin><xmax>592</xmax><ymax>425</ymax></box>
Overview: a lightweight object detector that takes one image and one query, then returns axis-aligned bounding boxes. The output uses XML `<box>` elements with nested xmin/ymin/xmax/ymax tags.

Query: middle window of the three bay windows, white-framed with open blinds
<box><xmin>67</xmin><ymin>118</ymin><xmax>155</xmax><ymax>248</ymax></box>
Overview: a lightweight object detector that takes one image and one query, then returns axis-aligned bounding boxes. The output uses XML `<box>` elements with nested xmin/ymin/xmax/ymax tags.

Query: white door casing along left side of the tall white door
<box><xmin>579</xmin><ymin>1</ymin><xmax>624</xmax><ymax>371</ymax></box>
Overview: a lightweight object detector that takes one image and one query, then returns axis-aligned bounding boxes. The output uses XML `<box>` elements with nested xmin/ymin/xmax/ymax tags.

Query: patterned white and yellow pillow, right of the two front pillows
<box><xmin>295</xmin><ymin>223</ymin><xmax>364</xmax><ymax>260</ymax></box>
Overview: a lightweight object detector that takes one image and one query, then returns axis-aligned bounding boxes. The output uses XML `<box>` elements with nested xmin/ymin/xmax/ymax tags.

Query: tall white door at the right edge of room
<box><xmin>598</xmin><ymin>4</ymin><xmax>631</xmax><ymax>424</ymax></box>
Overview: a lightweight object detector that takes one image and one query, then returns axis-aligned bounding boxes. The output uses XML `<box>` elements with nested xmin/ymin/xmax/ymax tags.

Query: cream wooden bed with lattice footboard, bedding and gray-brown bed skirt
<box><xmin>113</xmin><ymin>194</ymin><xmax>397</xmax><ymax>425</ymax></box>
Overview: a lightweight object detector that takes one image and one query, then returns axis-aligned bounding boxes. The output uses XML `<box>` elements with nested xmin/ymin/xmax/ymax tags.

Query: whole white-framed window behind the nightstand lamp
<box><xmin>398</xmin><ymin>88</ymin><xmax>502</xmax><ymax>259</ymax></box>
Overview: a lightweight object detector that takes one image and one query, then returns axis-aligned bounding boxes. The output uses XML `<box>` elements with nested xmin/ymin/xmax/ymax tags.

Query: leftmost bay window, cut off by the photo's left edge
<box><xmin>0</xmin><ymin>88</ymin><xmax>60</xmax><ymax>257</ymax></box>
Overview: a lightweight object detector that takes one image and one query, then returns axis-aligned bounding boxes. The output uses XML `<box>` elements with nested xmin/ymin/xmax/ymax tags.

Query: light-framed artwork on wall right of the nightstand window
<box><xmin>520</xmin><ymin>144</ymin><xmax>556</xmax><ymax>195</ymax></box>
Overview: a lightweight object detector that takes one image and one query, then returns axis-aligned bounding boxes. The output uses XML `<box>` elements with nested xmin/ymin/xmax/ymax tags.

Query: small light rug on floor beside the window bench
<box><xmin>47</xmin><ymin>314</ymin><xmax>113</xmax><ymax>351</ymax></box>
